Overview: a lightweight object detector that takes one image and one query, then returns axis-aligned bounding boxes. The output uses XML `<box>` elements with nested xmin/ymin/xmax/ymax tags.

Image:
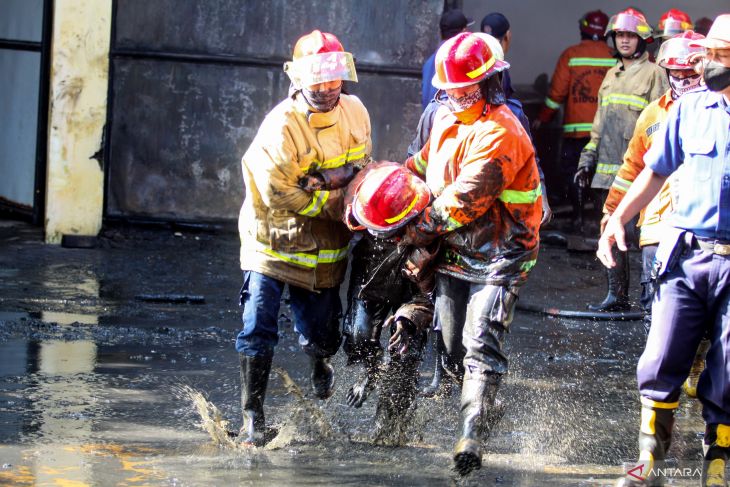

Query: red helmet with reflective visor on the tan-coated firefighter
<box><xmin>284</xmin><ymin>30</ymin><xmax>357</xmax><ymax>87</ymax></box>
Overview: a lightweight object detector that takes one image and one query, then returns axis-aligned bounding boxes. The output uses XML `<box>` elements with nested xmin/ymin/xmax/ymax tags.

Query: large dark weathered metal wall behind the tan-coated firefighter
<box><xmin>105</xmin><ymin>0</ymin><xmax>444</xmax><ymax>221</ymax></box>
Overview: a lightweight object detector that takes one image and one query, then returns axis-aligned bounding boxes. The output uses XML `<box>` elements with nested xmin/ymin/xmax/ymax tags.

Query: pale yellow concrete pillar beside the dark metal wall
<box><xmin>45</xmin><ymin>0</ymin><xmax>111</xmax><ymax>243</ymax></box>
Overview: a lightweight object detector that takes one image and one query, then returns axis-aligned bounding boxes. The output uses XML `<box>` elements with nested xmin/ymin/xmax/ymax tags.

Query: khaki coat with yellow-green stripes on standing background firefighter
<box><xmin>586</xmin><ymin>53</ymin><xmax>669</xmax><ymax>189</ymax></box>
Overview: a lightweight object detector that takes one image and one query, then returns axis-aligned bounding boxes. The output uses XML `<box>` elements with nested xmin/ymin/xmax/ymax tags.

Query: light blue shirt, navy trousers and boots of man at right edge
<box><xmin>624</xmin><ymin>91</ymin><xmax>730</xmax><ymax>484</ymax></box>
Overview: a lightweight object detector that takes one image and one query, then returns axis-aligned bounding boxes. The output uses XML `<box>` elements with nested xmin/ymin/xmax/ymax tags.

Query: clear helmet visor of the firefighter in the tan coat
<box><xmin>284</xmin><ymin>51</ymin><xmax>357</xmax><ymax>87</ymax></box>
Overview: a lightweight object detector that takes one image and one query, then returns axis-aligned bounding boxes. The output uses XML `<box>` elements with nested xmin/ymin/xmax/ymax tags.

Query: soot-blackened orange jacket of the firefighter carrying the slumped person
<box><xmin>406</xmin><ymin>102</ymin><xmax>542</xmax><ymax>285</ymax></box>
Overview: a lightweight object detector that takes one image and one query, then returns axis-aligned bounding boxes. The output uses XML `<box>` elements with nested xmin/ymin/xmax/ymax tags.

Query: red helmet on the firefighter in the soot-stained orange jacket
<box><xmin>431</xmin><ymin>32</ymin><xmax>509</xmax><ymax>90</ymax></box>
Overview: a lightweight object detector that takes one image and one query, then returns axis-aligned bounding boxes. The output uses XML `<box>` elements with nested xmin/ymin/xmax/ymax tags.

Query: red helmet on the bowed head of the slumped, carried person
<box><xmin>352</xmin><ymin>164</ymin><xmax>431</xmax><ymax>234</ymax></box>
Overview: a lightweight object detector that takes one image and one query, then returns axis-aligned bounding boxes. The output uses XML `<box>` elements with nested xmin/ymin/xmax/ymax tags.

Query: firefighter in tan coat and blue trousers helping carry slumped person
<box><xmin>236</xmin><ymin>30</ymin><xmax>371</xmax><ymax>445</ymax></box>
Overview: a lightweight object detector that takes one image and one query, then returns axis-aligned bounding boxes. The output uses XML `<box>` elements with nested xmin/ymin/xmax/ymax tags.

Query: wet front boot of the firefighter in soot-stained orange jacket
<box><xmin>454</xmin><ymin>374</ymin><xmax>502</xmax><ymax>475</ymax></box>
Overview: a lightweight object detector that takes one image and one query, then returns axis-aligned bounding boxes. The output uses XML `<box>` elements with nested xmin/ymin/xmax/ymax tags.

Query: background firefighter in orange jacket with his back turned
<box><xmin>533</xmin><ymin>10</ymin><xmax>616</xmax><ymax>225</ymax></box>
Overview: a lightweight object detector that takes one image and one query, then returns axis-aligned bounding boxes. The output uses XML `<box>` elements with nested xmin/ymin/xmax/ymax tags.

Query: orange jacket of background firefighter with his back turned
<box><xmin>538</xmin><ymin>39</ymin><xmax>617</xmax><ymax>138</ymax></box>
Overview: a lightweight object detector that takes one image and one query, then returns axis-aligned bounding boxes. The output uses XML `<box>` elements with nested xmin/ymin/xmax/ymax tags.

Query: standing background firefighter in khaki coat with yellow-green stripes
<box><xmin>575</xmin><ymin>8</ymin><xmax>669</xmax><ymax>311</ymax></box>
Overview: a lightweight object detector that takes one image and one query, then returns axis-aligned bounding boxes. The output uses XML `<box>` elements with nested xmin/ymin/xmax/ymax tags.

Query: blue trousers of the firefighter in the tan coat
<box><xmin>236</xmin><ymin>271</ymin><xmax>342</xmax><ymax>357</ymax></box>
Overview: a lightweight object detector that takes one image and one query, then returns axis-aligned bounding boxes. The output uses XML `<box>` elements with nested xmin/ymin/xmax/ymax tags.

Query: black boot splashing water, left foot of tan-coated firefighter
<box><xmin>238</xmin><ymin>353</ymin><xmax>274</xmax><ymax>446</ymax></box>
